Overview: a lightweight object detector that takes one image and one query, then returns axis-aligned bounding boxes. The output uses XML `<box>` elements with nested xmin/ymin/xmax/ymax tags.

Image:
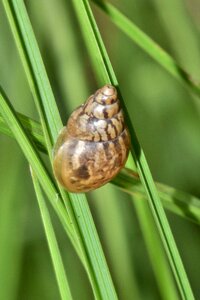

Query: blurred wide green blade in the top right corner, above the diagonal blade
<box><xmin>152</xmin><ymin>0</ymin><xmax>200</xmax><ymax>80</ymax></box>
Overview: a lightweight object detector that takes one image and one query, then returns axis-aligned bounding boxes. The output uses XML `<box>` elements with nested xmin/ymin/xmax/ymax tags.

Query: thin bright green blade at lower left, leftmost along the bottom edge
<box><xmin>31</xmin><ymin>169</ymin><xmax>73</xmax><ymax>300</ymax></box>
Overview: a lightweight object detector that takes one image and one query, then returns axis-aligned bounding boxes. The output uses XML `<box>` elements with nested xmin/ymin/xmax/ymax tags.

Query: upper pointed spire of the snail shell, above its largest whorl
<box><xmin>67</xmin><ymin>85</ymin><xmax>124</xmax><ymax>142</ymax></box>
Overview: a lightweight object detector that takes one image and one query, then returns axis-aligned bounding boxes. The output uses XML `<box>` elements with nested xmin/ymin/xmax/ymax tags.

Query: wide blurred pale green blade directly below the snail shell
<box><xmin>90</xmin><ymin>184</ymin><xmax>141</xmax><ymax>300</ymax></box>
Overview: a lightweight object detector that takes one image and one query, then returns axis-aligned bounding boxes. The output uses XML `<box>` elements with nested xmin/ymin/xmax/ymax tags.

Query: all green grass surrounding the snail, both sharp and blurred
<box><xmin>0</xmin><ymin>0</ymin><xmax>200</xmax><ymax>300</ymax></box>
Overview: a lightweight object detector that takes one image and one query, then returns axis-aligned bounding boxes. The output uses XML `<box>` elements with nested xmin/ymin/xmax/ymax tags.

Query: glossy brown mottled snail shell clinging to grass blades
<box><xmin>53</xmin><ymin>84</ymin><xmax>130</xmax><ymax>193</ymax></box>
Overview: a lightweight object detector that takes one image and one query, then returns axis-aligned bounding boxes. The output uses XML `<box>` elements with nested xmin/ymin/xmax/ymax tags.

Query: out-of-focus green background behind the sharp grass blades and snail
<box><xmin>0</xmin><ymin>0</ymin><xmax>200</xmax><ymax>300</ymax></box>
